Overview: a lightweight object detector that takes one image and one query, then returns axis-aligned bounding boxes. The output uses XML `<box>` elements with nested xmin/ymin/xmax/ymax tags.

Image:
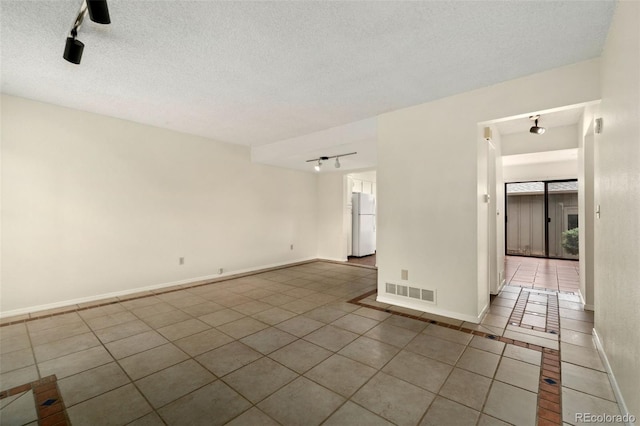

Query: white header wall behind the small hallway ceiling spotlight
<box><xmin>502</xmin><ymin>124</ymin><xmax>578</xmax><ymax>155</ymax></box>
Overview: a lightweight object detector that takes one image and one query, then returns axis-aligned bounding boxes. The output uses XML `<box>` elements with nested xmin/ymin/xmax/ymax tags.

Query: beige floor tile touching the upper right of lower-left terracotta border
<box><xmin>58</xmin><ymin>362</ymin><xmax>130</xmax><ymax>408</ymax></box>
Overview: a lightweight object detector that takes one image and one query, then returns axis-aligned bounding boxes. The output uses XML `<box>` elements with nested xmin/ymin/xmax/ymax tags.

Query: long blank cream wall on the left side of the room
<box><xmin>0</xmin><ymin>95</ymin><xmax>317</xmax><ymax>315</ymax></box>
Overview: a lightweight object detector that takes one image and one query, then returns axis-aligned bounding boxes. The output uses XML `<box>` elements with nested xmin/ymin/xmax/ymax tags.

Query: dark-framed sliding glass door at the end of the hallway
<box><xmin>505</xmin><ymin>179</ymin><xmax>579</xmax><ymax>260</ymax></box>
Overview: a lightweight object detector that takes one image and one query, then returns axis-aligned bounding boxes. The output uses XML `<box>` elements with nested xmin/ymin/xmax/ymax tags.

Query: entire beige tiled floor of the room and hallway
<box><xmin>0</xmin><ymin>262</ymin><xmax>618</xmax><ymax>425</ymax></box>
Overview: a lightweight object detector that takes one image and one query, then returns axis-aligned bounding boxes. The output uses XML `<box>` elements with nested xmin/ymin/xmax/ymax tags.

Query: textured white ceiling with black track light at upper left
<box><xmin>0</xmin><ymin>0</ymin><xmax>614</xmax><ymax>168</ymax></box>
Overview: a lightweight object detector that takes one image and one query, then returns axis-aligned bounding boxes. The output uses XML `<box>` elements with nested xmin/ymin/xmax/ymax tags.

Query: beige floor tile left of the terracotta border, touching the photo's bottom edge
<box><xmin>483</xmin><ymin>382</ymin><xmax>538</xmax><ymax>426</ymax></box>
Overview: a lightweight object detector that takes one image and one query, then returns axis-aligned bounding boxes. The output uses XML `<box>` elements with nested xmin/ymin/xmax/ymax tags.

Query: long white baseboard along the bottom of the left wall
<box><xmin>0</xmin><ymin>257</ymin><xmax>320</xmax><ymax>318</ymax></box>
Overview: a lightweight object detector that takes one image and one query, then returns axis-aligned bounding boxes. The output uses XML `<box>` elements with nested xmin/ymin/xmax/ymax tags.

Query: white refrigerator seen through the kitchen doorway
<box><xmin>352</xmin><ymin>192</ymin><xmax>376</xmax><ymax>257</ymax></box>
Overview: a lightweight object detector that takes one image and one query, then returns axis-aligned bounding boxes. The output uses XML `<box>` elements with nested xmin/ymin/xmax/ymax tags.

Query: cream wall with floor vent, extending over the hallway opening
<box><xmin>377</xmin><ymin>60</ymin><xmax>600</xmax><ymax>322</ymax></box>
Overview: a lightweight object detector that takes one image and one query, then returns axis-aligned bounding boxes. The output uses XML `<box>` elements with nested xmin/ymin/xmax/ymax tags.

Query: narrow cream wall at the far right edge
<box><xmin>594</xmin><ymin>1</ymin><xmax>640</xmax><ymax>417</ymax></box>
